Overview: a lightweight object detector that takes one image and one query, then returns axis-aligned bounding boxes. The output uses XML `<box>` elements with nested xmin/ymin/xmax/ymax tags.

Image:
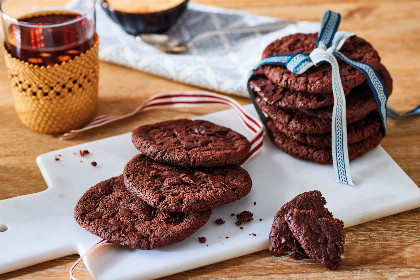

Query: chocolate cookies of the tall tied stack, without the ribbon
<box><xmin>250</xmin><ymin>33</ymin><xmax>392</xmax><ymax>163</ymax></box>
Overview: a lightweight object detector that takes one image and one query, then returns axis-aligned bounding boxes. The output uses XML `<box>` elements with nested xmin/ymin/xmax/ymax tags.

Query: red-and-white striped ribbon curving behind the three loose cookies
<box><xmin>60</xmin><ymin>91</ymin><xmax>263</xmax><ymax>165</ymax></box>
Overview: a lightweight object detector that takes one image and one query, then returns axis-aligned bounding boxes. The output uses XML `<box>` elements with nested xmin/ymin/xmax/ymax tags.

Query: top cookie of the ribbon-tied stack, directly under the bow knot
<box><xmin>262</xmin><ymin>33</ymin><xmax>381</xmax><ymax>94</ymax></box>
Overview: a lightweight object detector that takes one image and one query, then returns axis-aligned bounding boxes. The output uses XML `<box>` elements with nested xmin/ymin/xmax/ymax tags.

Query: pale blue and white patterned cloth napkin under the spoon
<box><xmin>94</xmin><ymin>0</ymin><xmax>319</xmax><ymax>96</ymax></box>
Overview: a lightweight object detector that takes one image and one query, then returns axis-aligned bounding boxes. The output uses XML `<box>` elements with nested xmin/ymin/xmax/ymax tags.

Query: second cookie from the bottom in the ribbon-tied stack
<box><xmin>270</xmin><ymin>111</ymin><xmax>382</xmax><ymax>149</ymax></box>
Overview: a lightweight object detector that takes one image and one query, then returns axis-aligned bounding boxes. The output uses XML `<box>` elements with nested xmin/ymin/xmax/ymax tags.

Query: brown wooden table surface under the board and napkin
<box><xmin>0</xmin><ymin>0</ymin><xmax>420</xmax><ymax>279</ymax></box>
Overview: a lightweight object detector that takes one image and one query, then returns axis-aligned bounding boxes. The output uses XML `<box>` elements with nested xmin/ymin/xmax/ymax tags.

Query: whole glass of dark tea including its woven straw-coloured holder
<box><xmin>0</xmin><ymin>0</ymin><xmax>98</xmax><ymax>133</ymax></box>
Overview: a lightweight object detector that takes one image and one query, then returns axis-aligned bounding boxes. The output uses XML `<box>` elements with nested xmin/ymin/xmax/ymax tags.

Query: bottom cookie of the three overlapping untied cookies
<box><xmin>74</xmin><ymin>175</ymin><xmax>211</xmax><ymax>250</ymax></box>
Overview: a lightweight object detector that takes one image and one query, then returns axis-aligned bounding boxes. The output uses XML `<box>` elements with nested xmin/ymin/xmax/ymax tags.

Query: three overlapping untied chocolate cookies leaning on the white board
<box><xmin>75</xmin><ymin>119</ymin><xmax>252</xmax><ymax>250</ymax></box>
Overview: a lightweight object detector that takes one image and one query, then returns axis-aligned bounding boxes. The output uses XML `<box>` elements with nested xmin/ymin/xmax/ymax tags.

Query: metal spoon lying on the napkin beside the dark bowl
<box><xmin>136</xmin><ymin>21</ymin><xmax>294</xmax><ymax>53</ymax></box>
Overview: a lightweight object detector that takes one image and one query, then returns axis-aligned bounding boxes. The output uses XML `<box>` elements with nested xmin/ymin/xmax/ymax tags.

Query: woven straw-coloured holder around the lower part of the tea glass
<box><xmin>4</xmin><ymin>37</ymin><xmax>99</xmax><ymax>133</ymax></box>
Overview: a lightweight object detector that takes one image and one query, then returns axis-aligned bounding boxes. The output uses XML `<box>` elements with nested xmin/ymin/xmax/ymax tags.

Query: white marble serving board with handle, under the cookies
<box><xmin>0</xmin><ymin>106</ymin><xmax>420</xmax><ymax>280</ymax></box>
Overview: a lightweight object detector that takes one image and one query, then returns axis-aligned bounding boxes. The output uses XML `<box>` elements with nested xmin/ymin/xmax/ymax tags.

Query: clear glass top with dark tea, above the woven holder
<box><xmin>1</xmin><ymin>0</ymin><xmax>96</xmax><ymax>66</ymax></box>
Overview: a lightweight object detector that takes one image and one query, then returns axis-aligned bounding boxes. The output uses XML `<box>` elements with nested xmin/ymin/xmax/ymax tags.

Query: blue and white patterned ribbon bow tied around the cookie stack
<box><xmin>248</xmin><ymin>10</ymin><xmax>388</xmax><ymax>185</ymax></box>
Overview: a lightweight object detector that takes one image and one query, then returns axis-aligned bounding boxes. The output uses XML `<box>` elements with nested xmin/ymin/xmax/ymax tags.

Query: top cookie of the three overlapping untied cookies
<box><xmin>132</xmin><ymin>119</ymin><xmax>251</xmax><ymax>167</ymax></box>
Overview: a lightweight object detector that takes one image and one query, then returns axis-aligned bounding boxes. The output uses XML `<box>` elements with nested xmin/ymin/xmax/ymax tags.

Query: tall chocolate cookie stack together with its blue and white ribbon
<box><xmin>248</xmin><ymin>11</ymin><xmax>392</xmax><ymax>185</ymax></box>
